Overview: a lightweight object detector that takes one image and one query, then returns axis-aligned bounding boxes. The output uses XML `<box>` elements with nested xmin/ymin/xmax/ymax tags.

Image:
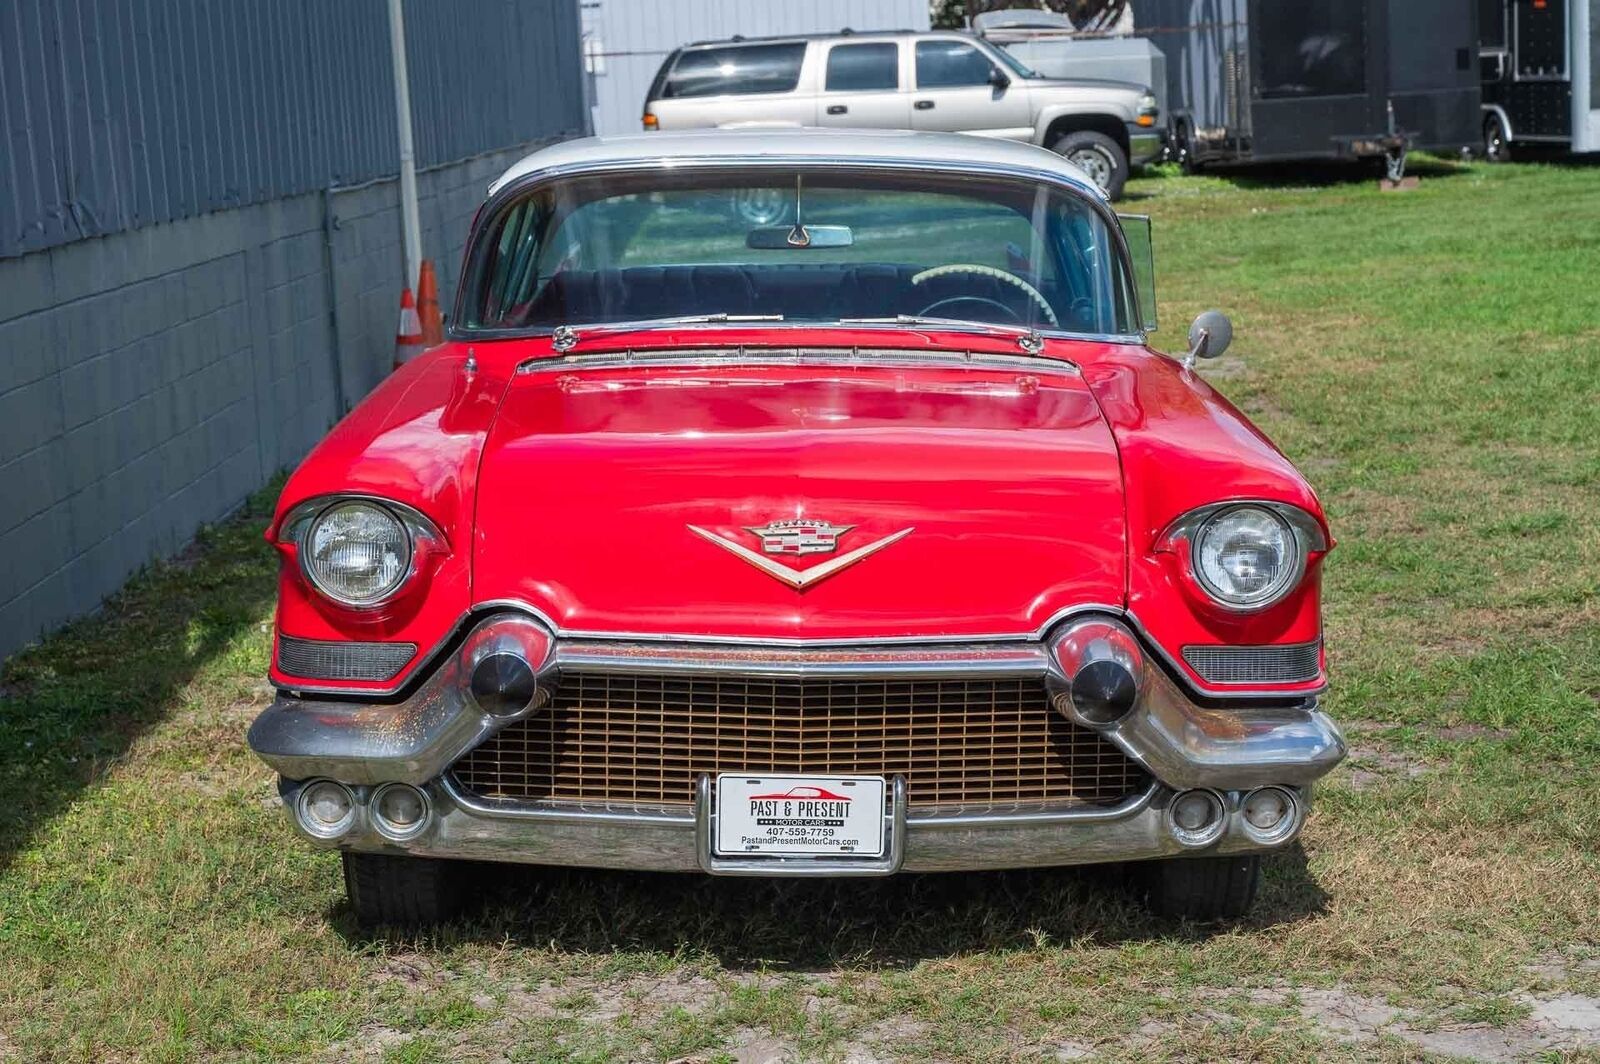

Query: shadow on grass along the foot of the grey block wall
<box><xmin>0</xmin><ymin>482</ymin><xmax>280</xmax><ymax>872</ymax></box>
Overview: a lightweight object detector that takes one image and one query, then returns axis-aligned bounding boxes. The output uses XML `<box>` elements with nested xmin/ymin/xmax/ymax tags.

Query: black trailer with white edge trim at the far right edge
<box><xmin>1478</xmin><ymin>0</ymin><xmax>1600</xmax><ymax>158</ymax></box>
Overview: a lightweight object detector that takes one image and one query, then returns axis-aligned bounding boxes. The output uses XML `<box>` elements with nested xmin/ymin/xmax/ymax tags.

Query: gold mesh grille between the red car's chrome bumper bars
<box><xmin>454</xmin><ymin>674</ymin><xmax>1149</xmax><ymax>805</ymax></box>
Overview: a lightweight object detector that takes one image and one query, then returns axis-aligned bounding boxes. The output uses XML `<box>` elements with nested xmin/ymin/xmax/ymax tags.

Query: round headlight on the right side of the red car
<box><xmin>1194</xmin><ymin>506</ymin><xmax>1306</xmax><ymax>608</ymax></box>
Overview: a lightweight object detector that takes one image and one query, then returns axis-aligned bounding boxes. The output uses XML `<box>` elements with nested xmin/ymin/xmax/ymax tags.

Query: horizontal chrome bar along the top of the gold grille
<box><xmin>555</xmin><ymin>640</ymin><xmax>1050</xmax><ymax>680</ymax></box>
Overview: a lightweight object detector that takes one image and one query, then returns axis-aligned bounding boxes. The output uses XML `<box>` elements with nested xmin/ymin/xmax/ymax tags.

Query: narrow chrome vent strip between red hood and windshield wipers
<box><xmin>517</xmin><ymin>344</ymin><xmax>1080</xmax><ymax>376</ymax></box>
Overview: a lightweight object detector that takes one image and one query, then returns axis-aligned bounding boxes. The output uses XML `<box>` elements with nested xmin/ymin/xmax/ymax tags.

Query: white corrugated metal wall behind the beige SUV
<box><xmin>584</xmin><ymin>0</ymin><xmax>928</xmax><ymax>134</ymax></box>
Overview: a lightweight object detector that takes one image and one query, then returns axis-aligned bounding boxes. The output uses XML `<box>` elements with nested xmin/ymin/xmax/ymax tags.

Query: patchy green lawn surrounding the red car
<box><xmin>0</xmin><ymin>153</ymin><xmax>1600</xmax><ymax>1061</ymax></box>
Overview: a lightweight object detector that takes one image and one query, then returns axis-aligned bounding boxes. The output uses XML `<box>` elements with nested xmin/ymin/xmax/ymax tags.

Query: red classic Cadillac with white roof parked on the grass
<box><xmin>250</xmin><ymin>131</ymin><xmax>1344</xmax><ymax>922</ymax></box>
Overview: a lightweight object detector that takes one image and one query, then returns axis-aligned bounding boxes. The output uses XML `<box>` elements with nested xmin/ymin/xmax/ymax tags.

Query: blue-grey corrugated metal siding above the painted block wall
<box><xmin>0</xmin><ymin>0</ymin><xmax>587</xmax><ymax>258</ymax></box>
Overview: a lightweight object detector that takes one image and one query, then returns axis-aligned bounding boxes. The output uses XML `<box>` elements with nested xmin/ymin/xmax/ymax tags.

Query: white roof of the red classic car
<box><xmin>490</xmin><ymin>126</ymin><xmax>1104</xmax><ymax>198</ymax></box>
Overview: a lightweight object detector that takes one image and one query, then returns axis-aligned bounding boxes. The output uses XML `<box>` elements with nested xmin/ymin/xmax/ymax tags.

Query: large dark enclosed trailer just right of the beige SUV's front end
<box><xmin>1131</xmin><ymin>0</ymin><xmax>1478</xmax><ymax>176</ymax></box>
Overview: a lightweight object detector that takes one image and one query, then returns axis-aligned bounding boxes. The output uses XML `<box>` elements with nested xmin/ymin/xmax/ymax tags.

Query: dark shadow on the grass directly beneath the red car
<box><xmin>344</xmin><ymin>843</ymin><xmax>1328</xmax><ymax>971</ymax></box>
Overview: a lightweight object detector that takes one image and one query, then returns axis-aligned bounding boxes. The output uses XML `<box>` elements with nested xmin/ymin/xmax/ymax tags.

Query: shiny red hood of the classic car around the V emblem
<box><xmin>472</xmin><ymin>356</ymin><xmax>1126</xmax><ymax>640</ymax></box>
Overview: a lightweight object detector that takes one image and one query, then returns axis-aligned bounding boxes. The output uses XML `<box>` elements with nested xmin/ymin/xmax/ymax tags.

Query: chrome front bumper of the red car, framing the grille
<box><xmin>250</xmin><ymin>614</ymin><xmax>1346</xmax><ymax>875</ymax></box>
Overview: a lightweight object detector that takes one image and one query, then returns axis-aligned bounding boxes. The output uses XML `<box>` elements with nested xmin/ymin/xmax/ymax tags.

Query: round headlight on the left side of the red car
<box><xmin>301</xmin><ymin>501</ymin><xmax>411</xmax><ymax>606</ymax></box>
